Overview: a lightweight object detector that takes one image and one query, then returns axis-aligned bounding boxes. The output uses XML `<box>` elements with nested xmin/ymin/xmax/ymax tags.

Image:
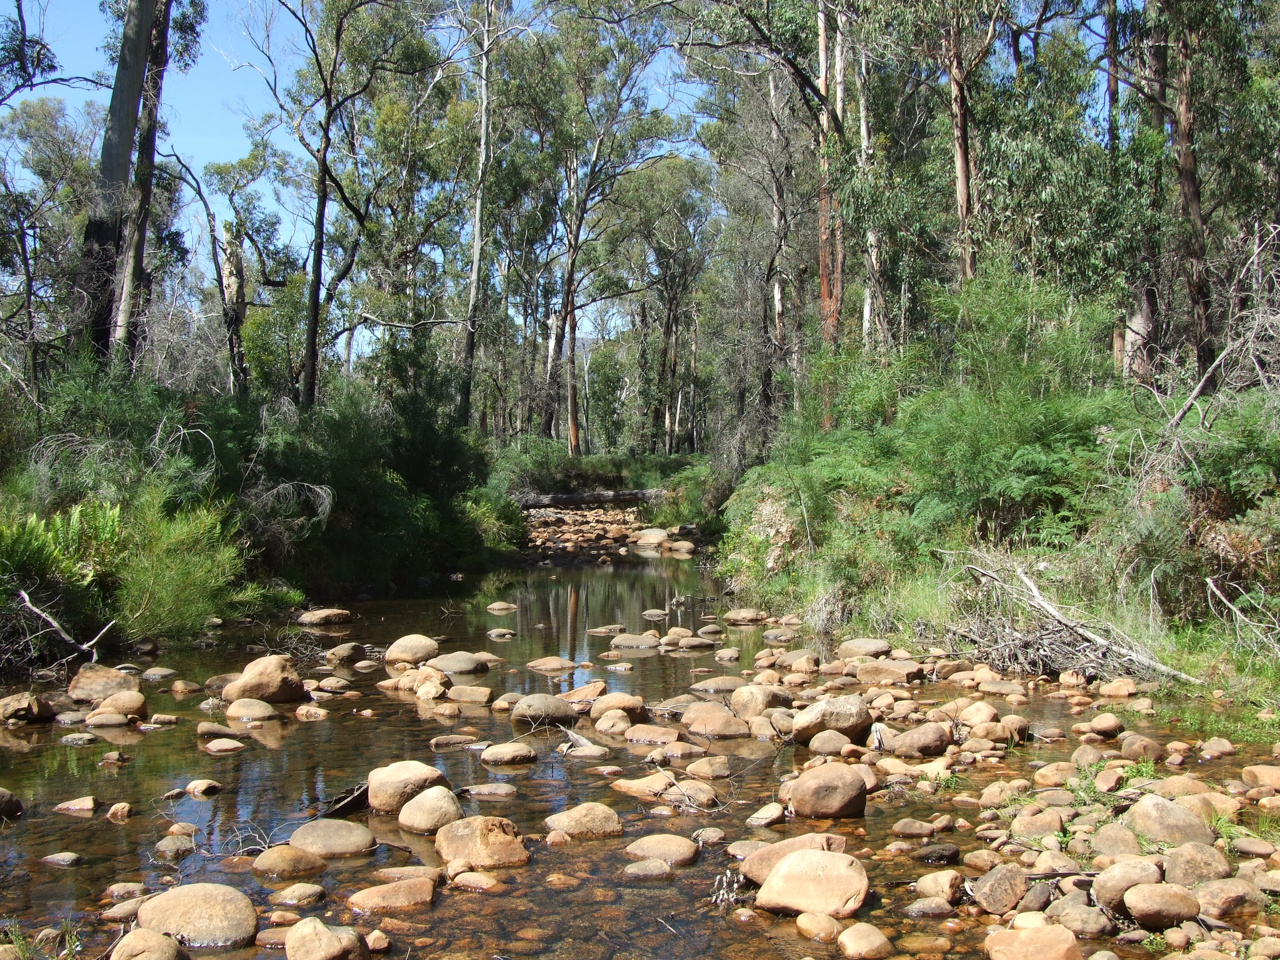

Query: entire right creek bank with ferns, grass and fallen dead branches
<box><xmin>721</xmin><ymin>270</ymin><xmax>1280</xmax><ymax>699</ymax></box>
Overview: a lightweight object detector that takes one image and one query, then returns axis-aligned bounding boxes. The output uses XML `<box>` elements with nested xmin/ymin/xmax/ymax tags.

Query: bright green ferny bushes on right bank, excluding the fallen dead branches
<box><xmin>723</xmin><ymin>264</ymin><xmax>1130</xmax><ymax>623</ymax></box>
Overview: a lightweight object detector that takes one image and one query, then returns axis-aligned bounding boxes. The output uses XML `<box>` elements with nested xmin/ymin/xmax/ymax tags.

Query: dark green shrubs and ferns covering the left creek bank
<box><xmin>0</xmin><ymin>365</ymin><xmax>501</xmax><ymax>667</ymax></box>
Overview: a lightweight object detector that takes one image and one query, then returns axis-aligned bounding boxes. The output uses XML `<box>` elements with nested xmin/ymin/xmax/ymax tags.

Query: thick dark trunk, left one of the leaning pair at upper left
<box><xmin>82</xmin><ymin>0</ymin><xmax>156</xmax><ymax>358</ymax></box>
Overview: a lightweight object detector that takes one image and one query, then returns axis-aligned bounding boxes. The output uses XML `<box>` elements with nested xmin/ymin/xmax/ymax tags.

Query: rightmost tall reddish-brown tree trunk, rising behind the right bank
<box><xmin>1175</xmin><ymin>27</ymin><xmax>1217</xmax><ymax>389</ymax></box>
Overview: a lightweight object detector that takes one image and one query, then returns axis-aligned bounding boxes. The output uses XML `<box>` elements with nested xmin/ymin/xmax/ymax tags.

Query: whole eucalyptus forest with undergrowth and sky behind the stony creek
<box><xmin>0</xmin><ymin>0</ymin><xmax>1280</xmax><ymax>695</ymax></box>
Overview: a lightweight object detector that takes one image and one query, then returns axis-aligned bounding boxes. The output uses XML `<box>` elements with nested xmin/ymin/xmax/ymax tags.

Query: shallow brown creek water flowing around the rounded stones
<box><xmin>0</xmin><ymin>561</ymin><xmax>1270</xmax><ymax>960</ymax></box>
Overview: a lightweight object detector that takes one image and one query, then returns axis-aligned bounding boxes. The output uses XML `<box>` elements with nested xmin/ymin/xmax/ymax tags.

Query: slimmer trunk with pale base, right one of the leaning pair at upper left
<box><xmin>111</xmin><ymin>0</ymin><xmax>173</xmax><ymax>362</ymax></box>
